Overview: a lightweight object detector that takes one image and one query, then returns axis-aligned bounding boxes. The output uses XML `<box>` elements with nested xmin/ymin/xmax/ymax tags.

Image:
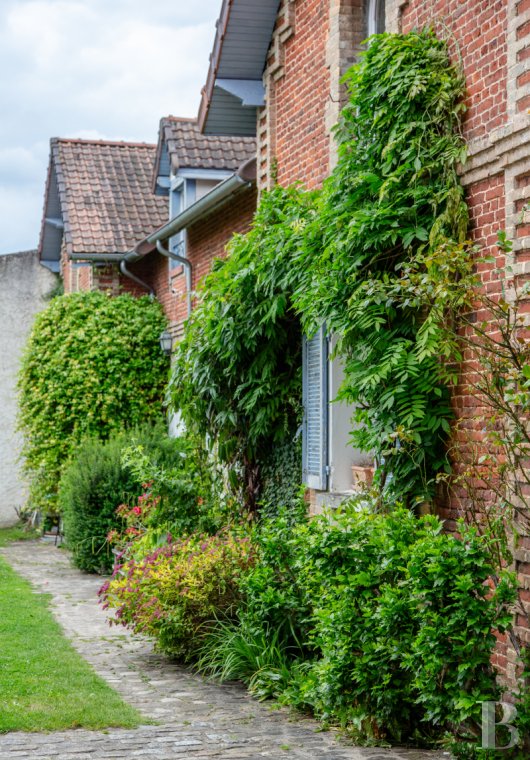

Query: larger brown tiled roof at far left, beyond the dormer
<box><xmin>51</xmin><ymin>138</ymin><xmax>168</xmax><ymax>254</ymax></box>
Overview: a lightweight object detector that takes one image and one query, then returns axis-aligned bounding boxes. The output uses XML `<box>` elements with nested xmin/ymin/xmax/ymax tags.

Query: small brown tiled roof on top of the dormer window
<box><xmin>155</xmin><ymin>116</ymin><xmax>256</xmax><ymax>183</ymax></box>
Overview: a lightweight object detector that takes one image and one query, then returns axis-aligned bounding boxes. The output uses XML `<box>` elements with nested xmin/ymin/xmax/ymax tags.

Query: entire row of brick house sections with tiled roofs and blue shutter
<box><xmin>36</xmin><ymin>0</ymin><xmax>530</xmax><ymax>676</ymax></box>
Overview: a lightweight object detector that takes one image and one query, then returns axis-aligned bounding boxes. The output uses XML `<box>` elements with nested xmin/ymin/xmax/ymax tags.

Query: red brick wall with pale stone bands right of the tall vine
<box><xmin>390</xmin><ymin>0</ymin><xmax>530</xmax><ymax>683</ymax></box>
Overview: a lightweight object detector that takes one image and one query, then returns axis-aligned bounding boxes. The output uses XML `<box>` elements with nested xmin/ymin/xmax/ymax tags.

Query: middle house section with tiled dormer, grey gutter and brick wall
<box><xmin>125</xmin><ymin>116</ymin><xmax>256</xmax><ymax>337</ymax></box>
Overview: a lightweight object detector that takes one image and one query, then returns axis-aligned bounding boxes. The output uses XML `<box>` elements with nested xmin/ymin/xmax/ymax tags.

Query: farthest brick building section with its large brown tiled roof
<box><xmin>39</xmin><ymin>138</ymin><xmax>167</xmax><ymax>293</ymax></box>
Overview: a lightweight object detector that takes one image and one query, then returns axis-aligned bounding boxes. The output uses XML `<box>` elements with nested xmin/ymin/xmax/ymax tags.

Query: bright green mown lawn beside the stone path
<box><xmin>0</xmin><ymin>531</ymin><xmax>144</xmax><ymax>733</ymax></box>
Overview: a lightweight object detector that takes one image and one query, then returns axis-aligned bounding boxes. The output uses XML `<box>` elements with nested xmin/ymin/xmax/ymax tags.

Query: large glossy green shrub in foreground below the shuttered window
<box><xmin>290</xmin><ymin>510</ymin><xmax>514</xmax><ymax>741</ymax></box>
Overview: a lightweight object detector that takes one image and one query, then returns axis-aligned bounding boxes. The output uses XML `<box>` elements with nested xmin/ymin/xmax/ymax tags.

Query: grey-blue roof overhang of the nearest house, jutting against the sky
<box><xmin>199</xmin><ymin>0</ymin><xmax>280</xmax><ymax>136</ymax></box>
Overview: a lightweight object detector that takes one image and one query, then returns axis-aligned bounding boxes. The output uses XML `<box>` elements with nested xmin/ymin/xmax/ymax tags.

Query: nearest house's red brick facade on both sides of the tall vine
<box><xmin>254</xmin><ymin>0</ymin><xmax>530</xmax><ymax>676</ymax></box>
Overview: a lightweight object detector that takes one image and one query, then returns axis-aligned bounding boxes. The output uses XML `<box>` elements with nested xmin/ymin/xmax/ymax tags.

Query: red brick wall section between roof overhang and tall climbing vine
<box><xmin>258</xmin><ymin>0</ymin><xmax>367</xmax><ymax>189</ymax></box>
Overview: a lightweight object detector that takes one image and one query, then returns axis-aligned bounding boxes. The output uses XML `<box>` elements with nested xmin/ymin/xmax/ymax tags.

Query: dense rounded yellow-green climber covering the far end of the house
<box><xmin>19</xmin><ymin>292</ymin><xmax>168</xmax><ymax>511</ymax></box>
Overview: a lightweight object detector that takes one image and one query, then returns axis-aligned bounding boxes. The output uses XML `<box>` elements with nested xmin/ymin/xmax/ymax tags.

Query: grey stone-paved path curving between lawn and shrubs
<box><xmin>0</xmin><ymin>542</ymin><xmax>448</xmax><ymax>760</ymax></box>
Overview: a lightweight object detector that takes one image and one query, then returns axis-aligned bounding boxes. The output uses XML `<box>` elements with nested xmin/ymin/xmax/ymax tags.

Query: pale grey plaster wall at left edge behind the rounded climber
<box><xmin>0</xmin><ymin>251</ymin><xmax>56</xmax><ymax>527</ymax></box>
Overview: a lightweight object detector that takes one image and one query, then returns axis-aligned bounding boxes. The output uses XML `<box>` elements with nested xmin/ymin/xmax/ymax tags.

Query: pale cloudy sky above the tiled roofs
<box><xmin>0</xmin><ymin>0</ymin><xmax>221</xmax><ymax>254</ymax></box>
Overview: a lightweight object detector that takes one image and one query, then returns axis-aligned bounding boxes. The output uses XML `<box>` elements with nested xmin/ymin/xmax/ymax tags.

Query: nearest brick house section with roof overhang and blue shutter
<box><xmin>199</xmin><ymin>0</ymin><xmax>530</xmax><ymax>676</ymax></box>
